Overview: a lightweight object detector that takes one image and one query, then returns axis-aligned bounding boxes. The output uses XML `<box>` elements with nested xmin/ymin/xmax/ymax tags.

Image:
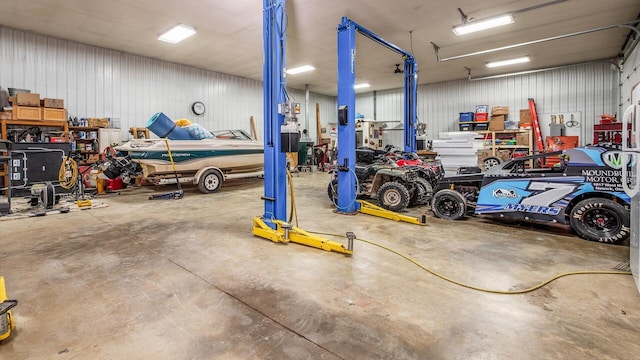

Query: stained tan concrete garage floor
<box><xmin>0</xmin><ymin>173</ymin><xmax>640</xmax><ymax>359</ymax></box>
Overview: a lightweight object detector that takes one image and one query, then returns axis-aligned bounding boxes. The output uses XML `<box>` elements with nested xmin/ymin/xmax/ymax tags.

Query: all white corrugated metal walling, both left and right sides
<box><xmin>0</xmin><ymin>26</ymin><xmax>628</xmax><ymax>145</ymax></box>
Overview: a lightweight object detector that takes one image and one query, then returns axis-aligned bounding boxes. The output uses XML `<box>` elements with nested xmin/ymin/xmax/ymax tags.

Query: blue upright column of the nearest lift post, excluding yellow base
<box><xmin>263</xmin><ymin>0</ymin><xmax>287</xmax><ymax>229</ymax></box>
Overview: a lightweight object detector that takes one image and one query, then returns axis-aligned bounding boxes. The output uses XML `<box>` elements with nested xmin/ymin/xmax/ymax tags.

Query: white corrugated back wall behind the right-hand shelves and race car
<box><xmin>356</xmin><ymin>63</ymin><xmax>617</xmax><ymax>145</ymax></box>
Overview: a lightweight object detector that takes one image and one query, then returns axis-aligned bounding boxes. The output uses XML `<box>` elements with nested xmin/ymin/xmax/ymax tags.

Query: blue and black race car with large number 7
<box><xmin>431</xmin><ymin>147</ymin><xmax>630</xmax><ymax>243</ymax></box>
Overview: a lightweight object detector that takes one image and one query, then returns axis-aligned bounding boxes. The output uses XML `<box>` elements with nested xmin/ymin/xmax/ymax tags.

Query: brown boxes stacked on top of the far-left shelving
<box><xmin>0</xmin><ymin>92</ymin><xmax>67</xmax><ymax>121</ymax></box>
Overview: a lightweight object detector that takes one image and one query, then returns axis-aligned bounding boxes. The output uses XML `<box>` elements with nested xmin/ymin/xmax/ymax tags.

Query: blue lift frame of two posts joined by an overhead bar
<box><xmin>338</xmin><ymin>17</ymin><xmax>418</xmax><ymax>214</ymax></box>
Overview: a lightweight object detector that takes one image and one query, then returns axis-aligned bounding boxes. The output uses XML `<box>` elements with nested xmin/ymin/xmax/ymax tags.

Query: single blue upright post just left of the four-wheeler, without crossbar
<box><xmin>337</xmin><ymin>17</ymin><xmax>359</xmax><ymax>214</ymax></box>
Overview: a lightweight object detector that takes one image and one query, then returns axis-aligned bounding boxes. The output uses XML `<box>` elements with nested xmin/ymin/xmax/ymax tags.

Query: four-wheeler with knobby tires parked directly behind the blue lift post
<box><xmin>327</xmin><ymin>149</ymin><xmax>430</xmax><ymax>211</ymax></box>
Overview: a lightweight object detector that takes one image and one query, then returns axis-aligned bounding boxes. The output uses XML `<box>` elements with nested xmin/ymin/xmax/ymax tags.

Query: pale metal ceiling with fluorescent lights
<box><xmin>0</xmin><ymin>0</ymin><xmax>640</xmax><ymax>95</ymax></box>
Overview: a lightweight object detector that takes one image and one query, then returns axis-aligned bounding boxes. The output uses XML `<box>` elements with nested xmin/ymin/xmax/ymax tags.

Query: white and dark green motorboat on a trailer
<box><xmin>115</xmin><ymin>130</ymin><xmax>264</xmax><ymax>192</ymax></box>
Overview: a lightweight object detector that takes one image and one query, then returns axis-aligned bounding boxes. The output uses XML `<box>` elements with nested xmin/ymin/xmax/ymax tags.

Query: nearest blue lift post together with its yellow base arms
<box><xmin>252</xmin><ymin>0</ymin><xmax>353</xmax><ymax>255</ymax></box>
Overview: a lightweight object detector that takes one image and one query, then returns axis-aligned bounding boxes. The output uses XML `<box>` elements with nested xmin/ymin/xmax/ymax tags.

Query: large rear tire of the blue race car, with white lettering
<box><xmin>570</xmin><ymin>198</ymin><xmax>631</xmax><ymax>244</ymax></box>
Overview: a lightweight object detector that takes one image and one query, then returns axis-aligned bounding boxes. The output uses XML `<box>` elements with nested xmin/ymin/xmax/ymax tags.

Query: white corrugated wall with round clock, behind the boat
<box><xmin>0</xmin><ymin>26</ymin><xmax>336</xmax><ymax>139</ymax></box>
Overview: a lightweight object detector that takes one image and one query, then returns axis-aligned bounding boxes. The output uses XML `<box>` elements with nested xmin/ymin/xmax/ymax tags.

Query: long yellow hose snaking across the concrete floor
<box><xmin>309</xmin><ymin>231</ymin><xmax>631</xmax><ymax>295</ymax></box>
